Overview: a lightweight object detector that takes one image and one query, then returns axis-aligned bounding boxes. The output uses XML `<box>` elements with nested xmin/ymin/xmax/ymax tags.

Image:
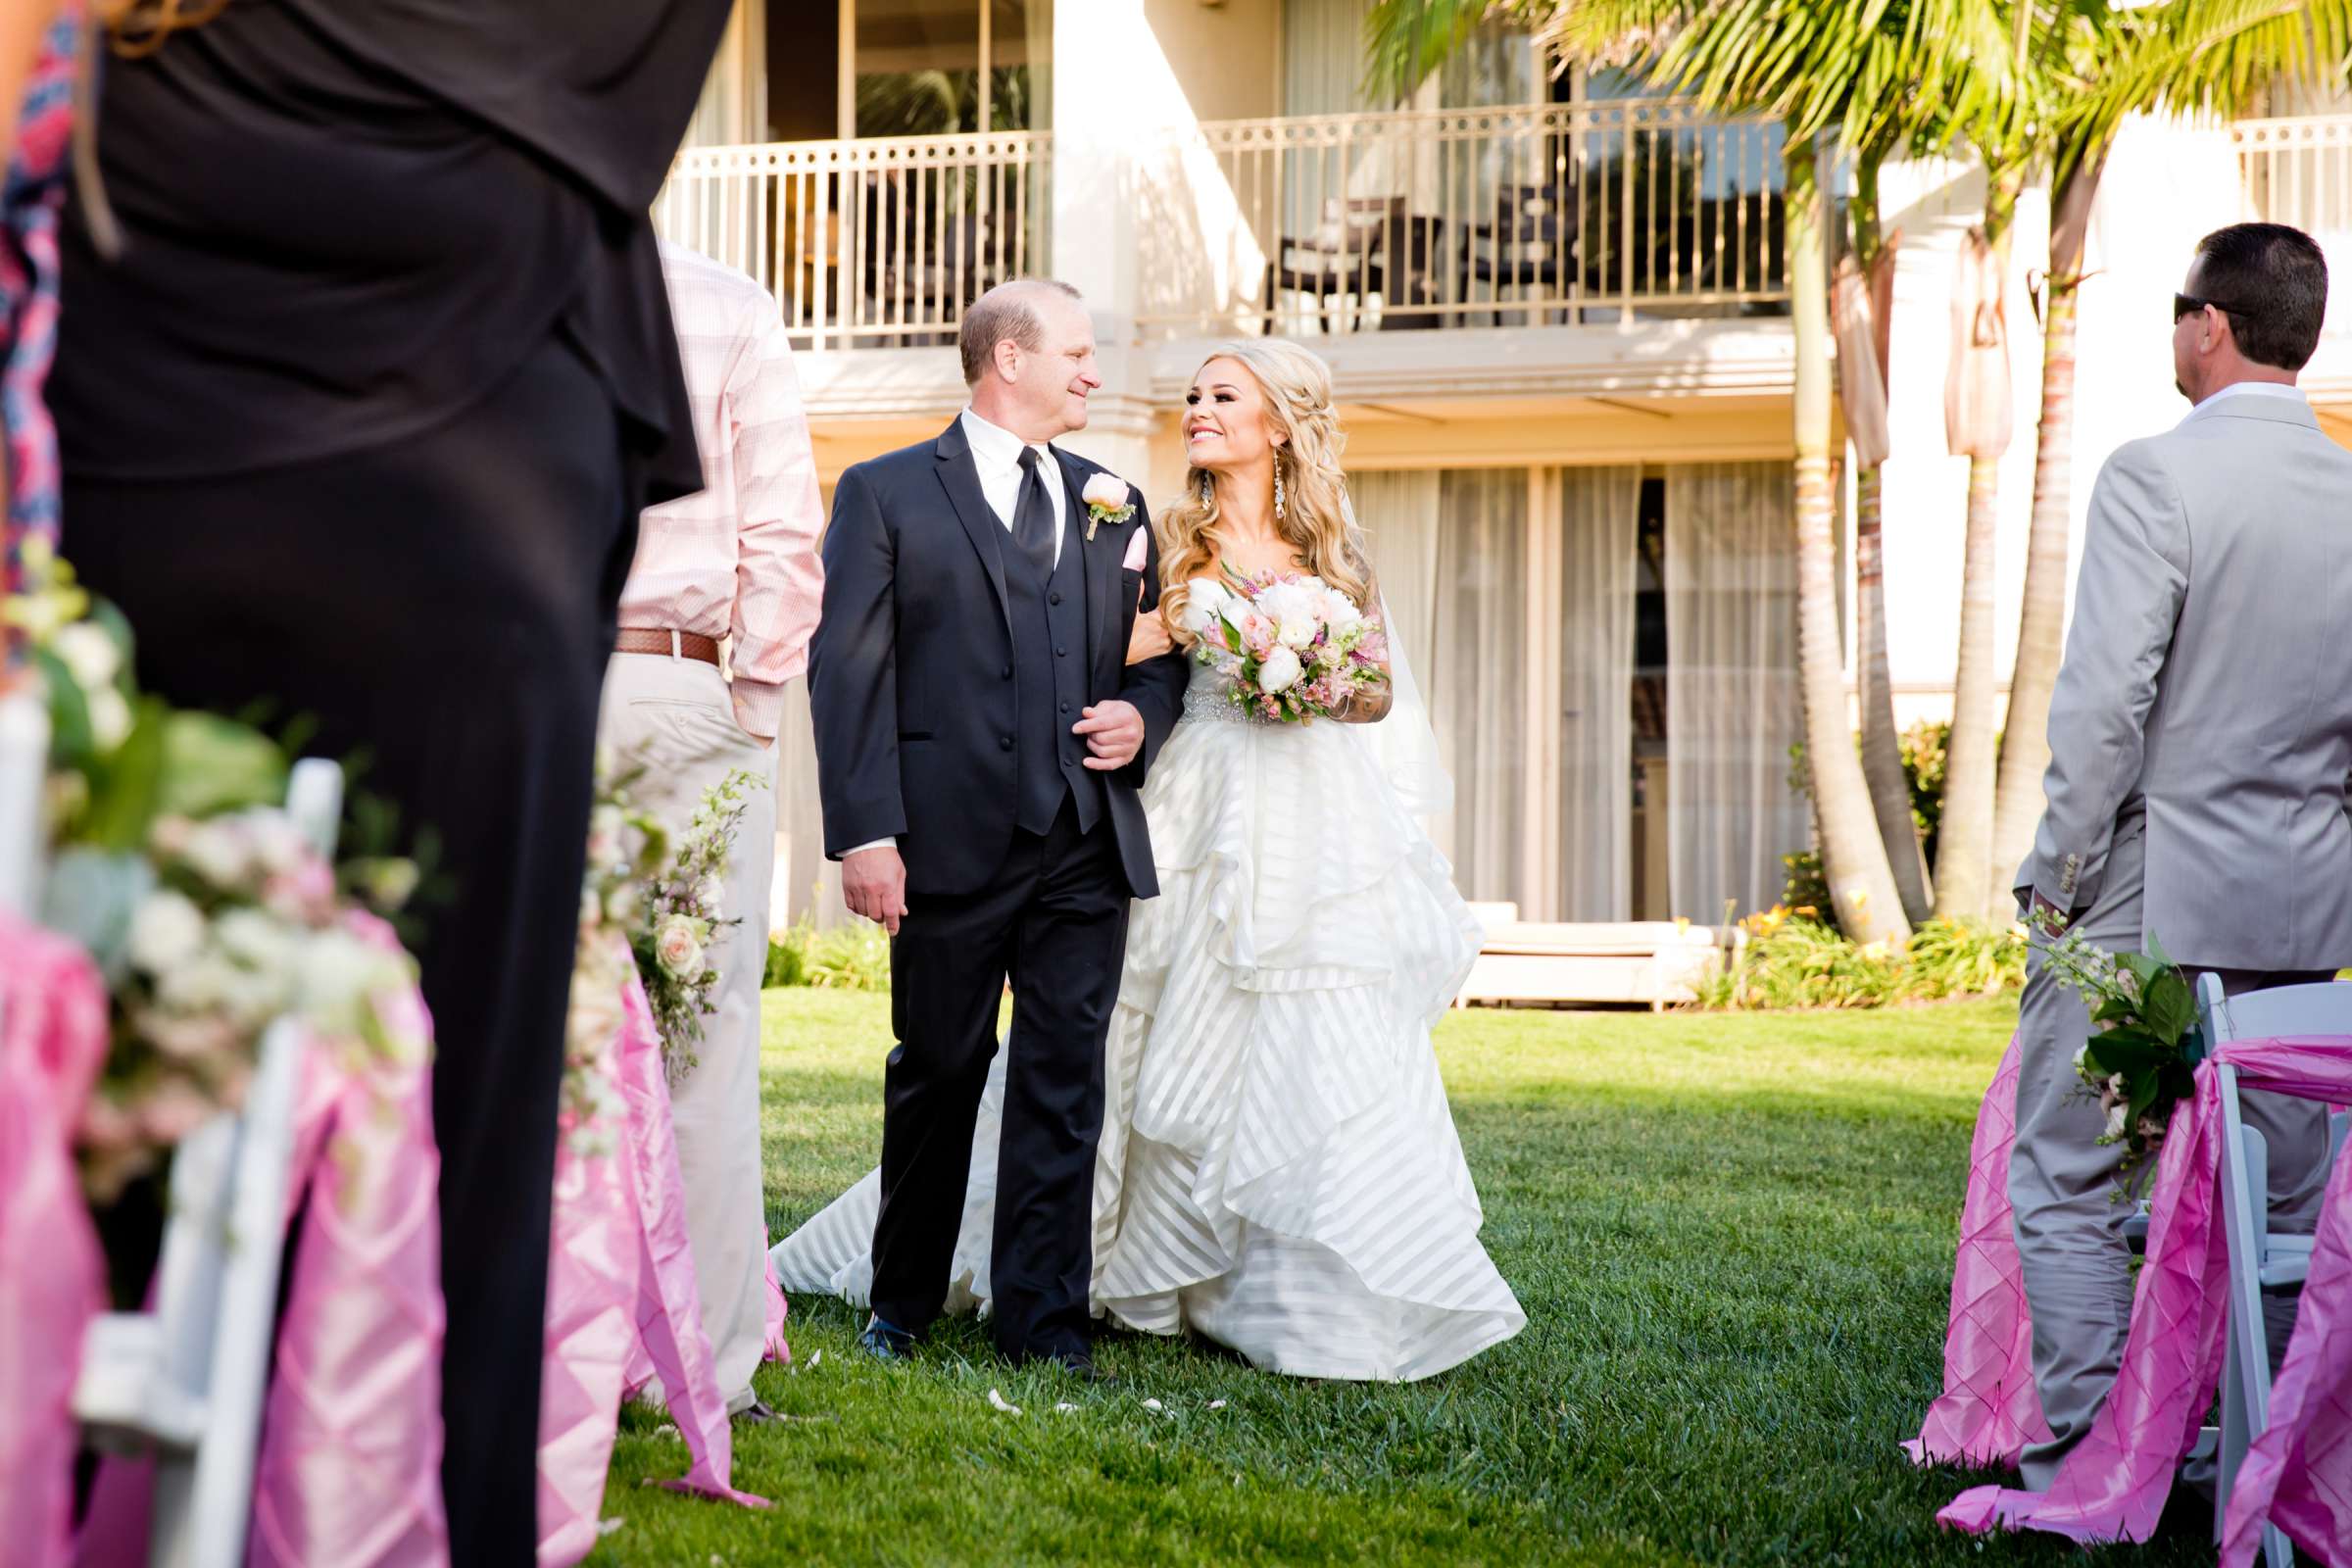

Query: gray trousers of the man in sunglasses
<box><xmin>2009</xmin><ymin>818</ymin><xmax>2328</xmax><ymax>1491</ymax></box>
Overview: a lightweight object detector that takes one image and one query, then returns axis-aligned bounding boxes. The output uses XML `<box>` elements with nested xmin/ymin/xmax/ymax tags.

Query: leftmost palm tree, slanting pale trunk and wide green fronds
<box><xmin>1366</xmin><ymin>0</ymin><xmax>1997</xmax><ymax>943</ymax></box>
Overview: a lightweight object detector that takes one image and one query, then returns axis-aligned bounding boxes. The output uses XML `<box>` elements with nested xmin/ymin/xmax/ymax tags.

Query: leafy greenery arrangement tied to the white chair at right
<box><xmin>2041</xmin><ymin>936</ymin><xmax>2197</xmax><ymax>1187</ymax></box>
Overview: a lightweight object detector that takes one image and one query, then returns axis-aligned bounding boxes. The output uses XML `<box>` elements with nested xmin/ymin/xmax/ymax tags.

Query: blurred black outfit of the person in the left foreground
<box><xmin>52</xmin><ymin>0</ymin><xmax>729</xmax><ymax>1568</ymax></box>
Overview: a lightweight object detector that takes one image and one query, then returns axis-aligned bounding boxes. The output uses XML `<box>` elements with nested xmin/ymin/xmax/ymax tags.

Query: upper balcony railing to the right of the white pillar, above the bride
<box><xmin>1136</xmin><ymin>99</ymin><xmax>1788</xmax><ymax>336</ymax></box>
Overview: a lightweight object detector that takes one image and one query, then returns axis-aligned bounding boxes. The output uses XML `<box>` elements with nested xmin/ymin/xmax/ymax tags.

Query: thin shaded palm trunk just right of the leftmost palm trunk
<box><xmin>1851</xmin><ymin>148</ymin><xmax>1934</xmax><ymax>926</ymax></box>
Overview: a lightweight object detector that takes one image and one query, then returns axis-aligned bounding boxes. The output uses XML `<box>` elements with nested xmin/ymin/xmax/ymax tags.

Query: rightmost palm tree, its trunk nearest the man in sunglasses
<box><xmin>1992</xmin><ymin>0</ymin><xmax>2352</xmax><ymax>893</ymax></box>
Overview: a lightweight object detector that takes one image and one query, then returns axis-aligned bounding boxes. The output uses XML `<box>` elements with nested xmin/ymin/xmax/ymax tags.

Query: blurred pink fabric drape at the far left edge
<box><xmin>0</xmin><ymin>914</ymin><xmax>108</xmax><ymax>1568</ymax></box>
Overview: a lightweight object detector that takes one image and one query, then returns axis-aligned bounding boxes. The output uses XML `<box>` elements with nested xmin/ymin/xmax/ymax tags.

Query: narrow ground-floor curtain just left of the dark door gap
<box><xmin>1559</xmin><ymin>467</ymin><xmax>1642</xmax><ymax>921</ymax></box>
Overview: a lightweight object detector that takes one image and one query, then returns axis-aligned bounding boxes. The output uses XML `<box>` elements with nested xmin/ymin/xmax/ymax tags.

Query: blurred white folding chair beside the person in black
<box><xmin>73</xmin><ymin>760</ymin><xmax>343</xmax><ymax>1568</ymax></box>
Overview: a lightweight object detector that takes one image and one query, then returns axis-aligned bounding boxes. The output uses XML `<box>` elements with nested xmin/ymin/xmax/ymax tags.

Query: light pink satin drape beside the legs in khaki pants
<box><xmin>539</xmin><ymin>945</ymin><xmax>766</xmax><ymax>1568</ymax></box>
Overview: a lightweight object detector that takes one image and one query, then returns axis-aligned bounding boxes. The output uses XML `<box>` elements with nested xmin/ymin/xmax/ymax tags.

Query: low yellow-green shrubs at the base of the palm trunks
<box><xmin>1695</xmin><ymin>907</ymin><xmax>2025</xmax><ymax>1010</ymax></box>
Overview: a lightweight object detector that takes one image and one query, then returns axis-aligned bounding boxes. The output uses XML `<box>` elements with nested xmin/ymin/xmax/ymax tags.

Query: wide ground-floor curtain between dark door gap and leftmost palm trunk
<box><xmin>1665</xmin><ymin>464</ymin><xmax>1811</xmax><ymax>921</ymax></box>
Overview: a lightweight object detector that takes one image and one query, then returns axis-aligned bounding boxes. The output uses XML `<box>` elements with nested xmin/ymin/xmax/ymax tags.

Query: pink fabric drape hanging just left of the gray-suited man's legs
<box><xmin>1903</xmin><ymin>1037</ymin><xmax>2051</xmax><ymax>1467</ymax></box>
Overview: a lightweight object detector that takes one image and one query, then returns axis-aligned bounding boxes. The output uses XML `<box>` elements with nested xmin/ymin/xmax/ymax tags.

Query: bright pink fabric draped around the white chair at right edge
<box><xmin>1922</xmin><ymin>1037</ymin><xmax>2352</xmax><ymax>1566</ymax></box>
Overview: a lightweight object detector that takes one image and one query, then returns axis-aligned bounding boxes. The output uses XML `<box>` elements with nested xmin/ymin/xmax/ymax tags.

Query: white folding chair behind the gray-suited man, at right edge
<box><xmin>2197</xmin><ymin>973</ymin><xmax>2352</xmax><ymax>1568</ymax></box>
